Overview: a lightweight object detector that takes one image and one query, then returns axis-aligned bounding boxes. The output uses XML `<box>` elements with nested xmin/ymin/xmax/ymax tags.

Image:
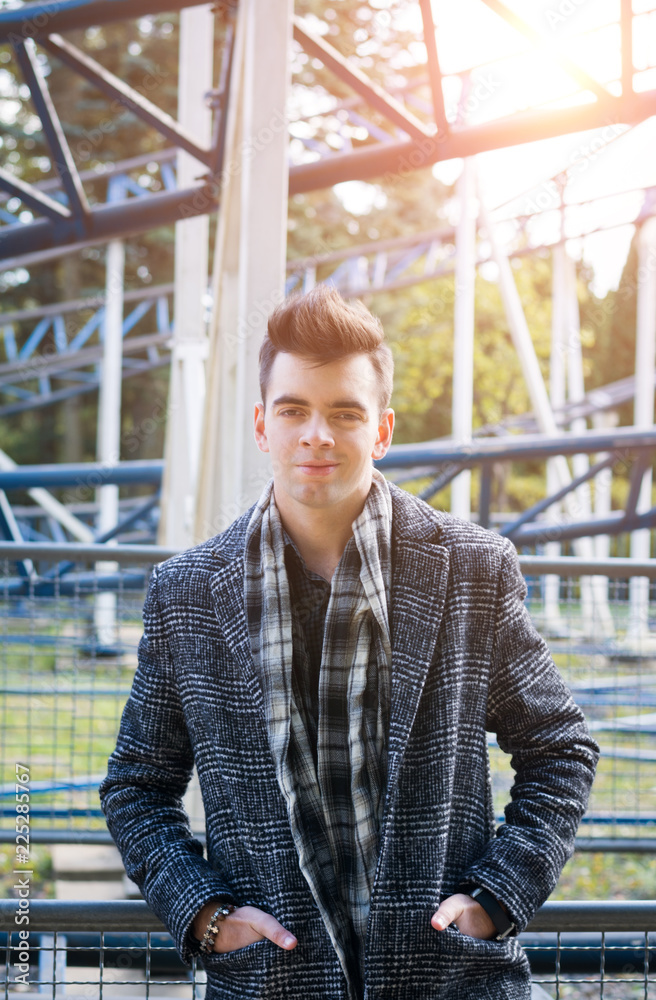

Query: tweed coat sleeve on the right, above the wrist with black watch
<box><xmin>456</xmin><ymin>541</ymin><xmax>599</xmax><ymax>931</ymax></box>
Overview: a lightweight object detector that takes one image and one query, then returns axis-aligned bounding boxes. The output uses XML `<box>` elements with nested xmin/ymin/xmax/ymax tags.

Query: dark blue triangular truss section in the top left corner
<box><xmin>0</xmin><ymin>0</ymin><xmax>234</xmax><ymax>259</ymax></box>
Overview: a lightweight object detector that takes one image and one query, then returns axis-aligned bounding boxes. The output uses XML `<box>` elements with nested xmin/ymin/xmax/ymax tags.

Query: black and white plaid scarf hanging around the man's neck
<box><xmin>244</xmin><ymin>469</ymin><xmax>392</xmax><ymax>997</ymax></box>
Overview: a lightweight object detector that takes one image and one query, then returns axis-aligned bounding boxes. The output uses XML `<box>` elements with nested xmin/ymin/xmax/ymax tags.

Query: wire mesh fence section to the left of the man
<box><xmin>0</xmin><ymin>548</ymin><xmax>155</xmax><ymax>830</ymax></box>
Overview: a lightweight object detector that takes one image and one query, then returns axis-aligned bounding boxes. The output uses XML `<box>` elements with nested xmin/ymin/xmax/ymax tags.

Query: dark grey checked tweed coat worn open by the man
<box><xmin>100</xmin><ymin>486</ymin><xmax>598</xmax><ymax>1000</ymax></box>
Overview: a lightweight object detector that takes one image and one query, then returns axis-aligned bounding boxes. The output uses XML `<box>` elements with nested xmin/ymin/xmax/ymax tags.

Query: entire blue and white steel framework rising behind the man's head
<box><xmin>0</xmin><ymin>0</ymin><xmax>656</xmax><ymax>608</ymax></box>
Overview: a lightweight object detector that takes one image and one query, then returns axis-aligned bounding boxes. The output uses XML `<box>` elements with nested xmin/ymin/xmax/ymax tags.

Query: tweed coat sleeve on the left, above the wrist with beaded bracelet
<box><xmin>99</xmin><ymin>568</ymin><xmax>230</xmax><ymax>964</ymax></box>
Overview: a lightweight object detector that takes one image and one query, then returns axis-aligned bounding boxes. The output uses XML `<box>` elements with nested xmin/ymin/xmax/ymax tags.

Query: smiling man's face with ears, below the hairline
<box><xmin>255</xmin><ymin>353</ymin><xmax>394</xmax><ymax>507</ymax></box>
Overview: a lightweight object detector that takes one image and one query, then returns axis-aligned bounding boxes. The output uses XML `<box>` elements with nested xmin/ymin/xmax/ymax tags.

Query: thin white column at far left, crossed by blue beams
<box><xmin>94</xmin><ymin>240</ymin><xmax>125</xmax><ymax>649</ymax></box>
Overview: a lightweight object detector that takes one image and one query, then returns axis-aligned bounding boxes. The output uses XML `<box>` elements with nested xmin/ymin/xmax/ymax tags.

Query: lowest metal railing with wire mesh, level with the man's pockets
<box><xmin>0</xmin><ymin>899</ymin><xmax>656</xmax><ymax>1000</ymax></box>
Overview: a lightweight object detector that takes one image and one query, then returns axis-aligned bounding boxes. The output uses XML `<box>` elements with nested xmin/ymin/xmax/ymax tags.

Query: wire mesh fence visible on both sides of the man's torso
<box><xmin>0</xmin><ymin>545</ymin><xmax>656</xmax><ymax>842</ymax></box>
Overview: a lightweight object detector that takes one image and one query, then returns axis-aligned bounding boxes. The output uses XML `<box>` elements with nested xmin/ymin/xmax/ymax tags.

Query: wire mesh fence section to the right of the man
<box><xmin>490</xmin><ymin>558</ymin><xmax>656</xmax><ymax>840</ymax></box>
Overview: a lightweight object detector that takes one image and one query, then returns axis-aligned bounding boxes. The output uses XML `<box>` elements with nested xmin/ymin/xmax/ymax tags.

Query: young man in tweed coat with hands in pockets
<box><xmin>100</xmin><ymin>286</ymin><xmax>598</xmax><ymax>1000</ymax></box>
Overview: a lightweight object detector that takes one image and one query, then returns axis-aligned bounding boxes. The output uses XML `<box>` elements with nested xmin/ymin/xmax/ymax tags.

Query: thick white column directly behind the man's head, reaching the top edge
<box><xmin>196</xmin><ymin>0</ymin><xmax>292</xmax><ymax>538</ymax></box>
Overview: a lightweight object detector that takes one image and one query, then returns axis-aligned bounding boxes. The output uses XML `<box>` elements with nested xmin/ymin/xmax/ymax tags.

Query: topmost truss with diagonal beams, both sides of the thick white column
<box><xmin>0</xmin><ymin>0</ymin><xmax>656</xmax><ymax>257</ymax></box>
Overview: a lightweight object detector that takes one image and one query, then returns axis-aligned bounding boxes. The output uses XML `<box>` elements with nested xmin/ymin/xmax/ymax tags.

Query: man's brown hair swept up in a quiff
<box><xmin>260</xmin><ymin>285</ymin><xmax>394</xmax><ymax>413</ymax></box>
